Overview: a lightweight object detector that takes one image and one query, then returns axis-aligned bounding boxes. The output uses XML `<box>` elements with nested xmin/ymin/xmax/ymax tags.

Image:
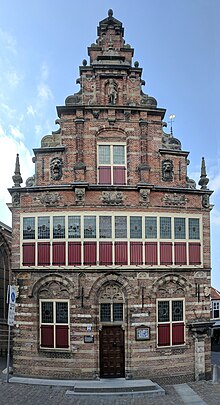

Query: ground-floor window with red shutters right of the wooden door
<box><xmin>157</xmin><ymin>299</ymin><xmax>185</xmax><ymax>346</ymax></box>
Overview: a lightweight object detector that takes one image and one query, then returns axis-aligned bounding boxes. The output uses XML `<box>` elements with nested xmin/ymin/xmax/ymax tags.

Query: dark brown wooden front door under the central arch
<box><xmin>100</xmin><ymin>326</ymin><xmax>125</xmax><ymax>378</ymax></box>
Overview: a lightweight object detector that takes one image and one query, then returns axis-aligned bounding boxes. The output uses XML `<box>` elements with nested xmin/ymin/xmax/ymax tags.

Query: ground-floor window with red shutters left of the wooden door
<box><xmin>40</xmin><ymin>300</ymin><xmax>69</xmax><ymax>349</ymax></box>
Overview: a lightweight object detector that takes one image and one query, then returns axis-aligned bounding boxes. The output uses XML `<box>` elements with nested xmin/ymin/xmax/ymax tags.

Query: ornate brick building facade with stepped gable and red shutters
<box><xmin>9</xmin><ymin>10</ymin><xmax>211</xmax><ymax>381</ymax></box>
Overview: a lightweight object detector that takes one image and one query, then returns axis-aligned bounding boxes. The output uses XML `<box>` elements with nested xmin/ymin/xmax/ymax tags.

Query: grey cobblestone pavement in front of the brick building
<box><xmin>0</xmin><ymin>380</ymin><xmax>220</xmax><ymax>405</ymax></box>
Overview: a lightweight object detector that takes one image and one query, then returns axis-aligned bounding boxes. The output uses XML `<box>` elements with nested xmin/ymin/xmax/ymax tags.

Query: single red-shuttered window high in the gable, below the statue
<box><xmin>98</xmin><ymin>144</ymin><xmax>126</xmax><ymax>185</ymax></box>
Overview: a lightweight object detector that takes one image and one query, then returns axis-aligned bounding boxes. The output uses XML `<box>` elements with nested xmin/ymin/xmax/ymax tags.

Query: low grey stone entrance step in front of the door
<box><xmin>66</xmin><ymin>378</ymin><xmax>165</xmax><ymax>396</ymax></box>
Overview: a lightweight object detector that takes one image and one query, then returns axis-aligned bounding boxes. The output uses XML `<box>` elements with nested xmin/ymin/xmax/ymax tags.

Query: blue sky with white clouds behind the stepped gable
<box><xmin>0</xmin><ymin>0</ymin><xmax>220</xmax><ymax>289</ymax></box>
